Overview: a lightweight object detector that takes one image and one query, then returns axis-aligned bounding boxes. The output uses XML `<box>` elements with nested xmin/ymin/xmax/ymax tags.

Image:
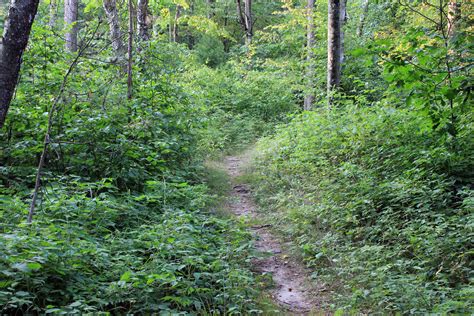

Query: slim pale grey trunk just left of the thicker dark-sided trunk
<box><xmin>304</xmin><ymin>0</ymin><xmax>314</xmax><ymax>110</ymax></box>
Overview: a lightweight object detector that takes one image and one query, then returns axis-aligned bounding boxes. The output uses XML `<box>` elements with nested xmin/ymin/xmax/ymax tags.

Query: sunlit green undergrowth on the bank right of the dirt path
<box><xmin>252</xmin><ymin>106</ymin><xmax>474</xmax><ymax>313</ymax></box>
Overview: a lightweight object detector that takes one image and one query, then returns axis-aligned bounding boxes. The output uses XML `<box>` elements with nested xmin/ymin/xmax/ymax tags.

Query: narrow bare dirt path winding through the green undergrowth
<box><xmin>225</xmin><ymin>156</ymin><xmax>325</xmax><ymax>315</ymax></box>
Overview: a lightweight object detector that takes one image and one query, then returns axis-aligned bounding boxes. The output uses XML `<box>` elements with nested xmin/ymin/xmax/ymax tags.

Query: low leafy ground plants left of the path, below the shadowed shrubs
<box><xmin>0</xmin><ymin>181</ymin><xmax>257</xmax><ymax>314</ymax></box>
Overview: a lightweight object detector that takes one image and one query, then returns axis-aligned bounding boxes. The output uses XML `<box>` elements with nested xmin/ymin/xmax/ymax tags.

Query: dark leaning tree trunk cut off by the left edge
<box><xmin>0</xmin><ymin>0</ymin><xmax>39</xmax><ymax>128</ymax></box>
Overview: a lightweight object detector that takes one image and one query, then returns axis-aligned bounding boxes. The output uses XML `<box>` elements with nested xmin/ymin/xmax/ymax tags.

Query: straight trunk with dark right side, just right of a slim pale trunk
<box><xmin>327</xmin><ymin>0</ymin><xmax>344</xmax><ymax>105</ymax></box>
